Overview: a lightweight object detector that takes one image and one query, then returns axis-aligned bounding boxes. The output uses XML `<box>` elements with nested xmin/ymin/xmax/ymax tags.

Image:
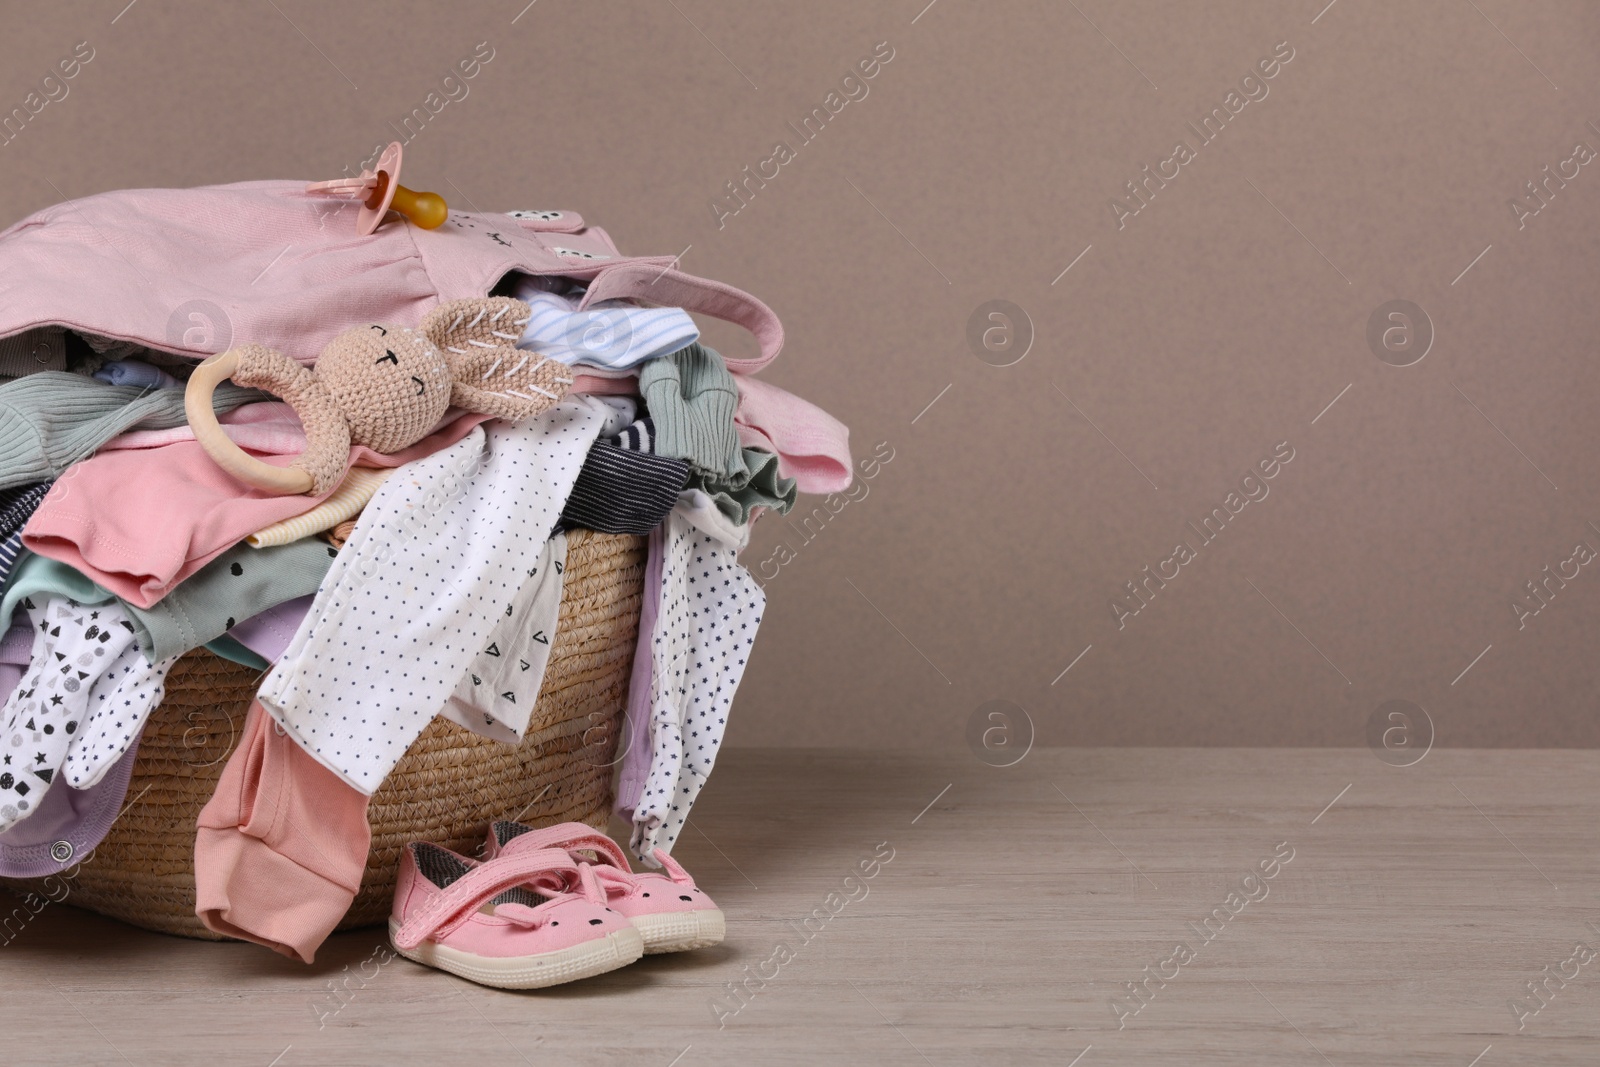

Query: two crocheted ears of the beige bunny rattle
<box><xmin>422</xmin><ymin>296</ymin><xmax>573</xmax><ymax>422</ymax></box>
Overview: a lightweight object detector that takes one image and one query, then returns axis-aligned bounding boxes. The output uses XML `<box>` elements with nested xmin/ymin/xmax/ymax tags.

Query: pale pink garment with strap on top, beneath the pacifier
<box><xmin>0</xmin><ymin>181</ymin><xmax>784</xmax><ymax>374</ymax></box>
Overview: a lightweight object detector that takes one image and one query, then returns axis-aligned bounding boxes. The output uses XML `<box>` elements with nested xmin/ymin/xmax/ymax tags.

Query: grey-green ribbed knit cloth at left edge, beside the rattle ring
<box><xmin>0</xmin><ymin>371</ymin><xmax>267</xmax><ymax>490</ymax></box>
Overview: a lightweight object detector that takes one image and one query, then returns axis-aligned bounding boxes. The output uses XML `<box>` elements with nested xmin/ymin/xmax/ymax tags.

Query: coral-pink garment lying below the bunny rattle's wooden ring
<box><xmin>22</xmin><ymin>414</ymin><xmax>488</xmax><ymax>608</ymax></box>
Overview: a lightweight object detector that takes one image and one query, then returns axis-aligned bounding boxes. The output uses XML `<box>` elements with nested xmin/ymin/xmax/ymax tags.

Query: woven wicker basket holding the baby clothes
<box><xmin>0</xmin><ymin>530</ymin><xmax>645</xmax><ymax>941</ymax></box>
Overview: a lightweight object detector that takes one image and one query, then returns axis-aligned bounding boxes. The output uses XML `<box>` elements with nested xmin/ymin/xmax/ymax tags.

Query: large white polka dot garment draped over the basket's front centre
<box><xmin>259</xmin><ymin>397</ymin><xmax>610</xmax><ymax>795</ymax></box>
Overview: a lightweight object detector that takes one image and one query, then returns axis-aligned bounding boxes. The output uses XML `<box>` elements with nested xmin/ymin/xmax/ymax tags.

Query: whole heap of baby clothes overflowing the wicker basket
<box><xmin>0</xmin><ymin>182</ymin><xmax>851</xmax><ymax>961</ymax></box>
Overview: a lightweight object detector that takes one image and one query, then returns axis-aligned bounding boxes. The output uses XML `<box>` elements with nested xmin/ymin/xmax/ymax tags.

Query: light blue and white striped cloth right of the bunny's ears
<box><xmin>514</xmin><ymin>277</ymin><xmax>699</xmax><ymax>371</ymax></box>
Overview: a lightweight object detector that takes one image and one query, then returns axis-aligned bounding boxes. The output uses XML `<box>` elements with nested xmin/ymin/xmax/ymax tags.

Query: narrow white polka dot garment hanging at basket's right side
<box><xmin>630</xmin><ymin>514</ymin><xmax>766</xmax><ymax>857</ymax></box>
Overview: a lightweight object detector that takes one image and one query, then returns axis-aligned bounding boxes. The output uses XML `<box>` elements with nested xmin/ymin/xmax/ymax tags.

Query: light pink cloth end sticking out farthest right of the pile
<box><xmin>733</xmin><ymin>374</ymin><xmax>856</xmax><ymax>493</ymax></box>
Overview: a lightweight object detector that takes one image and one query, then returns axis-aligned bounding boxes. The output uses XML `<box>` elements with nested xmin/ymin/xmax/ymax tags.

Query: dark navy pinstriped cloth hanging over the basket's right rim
<box><xmin>557</xmin><ymin>441</ymin><xmax>690</xmax><ymax>536</ymax></box>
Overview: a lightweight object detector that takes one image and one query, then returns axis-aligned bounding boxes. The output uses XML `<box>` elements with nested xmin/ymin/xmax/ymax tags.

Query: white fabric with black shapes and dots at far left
<box><xmin>0</xmin><ymin>597</ymin><xmax>173</xmax><ymax>830</ymax></box>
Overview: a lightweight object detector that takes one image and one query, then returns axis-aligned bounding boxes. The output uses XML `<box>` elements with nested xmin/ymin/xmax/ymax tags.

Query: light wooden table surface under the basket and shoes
<box><xmin>0</xmin><ymin>749</ymin><xmax>1600</xmax><ymax>1067</ymax></box>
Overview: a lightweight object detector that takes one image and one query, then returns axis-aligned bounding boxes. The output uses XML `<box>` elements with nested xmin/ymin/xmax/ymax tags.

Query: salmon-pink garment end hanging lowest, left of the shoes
<box><xmin>195</xmin><ymin>702</ymin><xmax>373</xmax><ymax>963</ymax></box>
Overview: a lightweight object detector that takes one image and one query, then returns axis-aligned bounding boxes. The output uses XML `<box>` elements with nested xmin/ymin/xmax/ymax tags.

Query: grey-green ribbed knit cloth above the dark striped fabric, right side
<box><xmin>638</xmin><ymin>342</ymin><xmax>746</xmax><ymax>478</ymax></box>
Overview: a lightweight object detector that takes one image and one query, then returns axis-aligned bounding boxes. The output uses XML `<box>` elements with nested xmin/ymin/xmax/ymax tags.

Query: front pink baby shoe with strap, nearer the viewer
<box><xmin>389</xmin><ymin>841</ymin><xmax>645</xmax><ymax>989</ymax></box>
